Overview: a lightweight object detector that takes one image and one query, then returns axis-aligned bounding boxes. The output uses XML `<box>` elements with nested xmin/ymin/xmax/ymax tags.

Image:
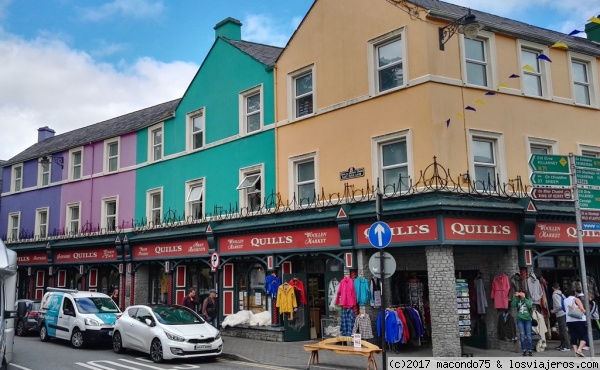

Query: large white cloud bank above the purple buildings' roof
<box><xmin>0</xmin><ymin>30</ymin><xmax>198</xmax><ymax>159</ymax></box>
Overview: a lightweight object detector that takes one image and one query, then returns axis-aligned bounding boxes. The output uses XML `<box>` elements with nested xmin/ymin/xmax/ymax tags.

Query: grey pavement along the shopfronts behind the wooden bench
<box><xmin>222</xmin><ymin>336</ymin><xmax>600</xmax><ymax>370</ymax></box>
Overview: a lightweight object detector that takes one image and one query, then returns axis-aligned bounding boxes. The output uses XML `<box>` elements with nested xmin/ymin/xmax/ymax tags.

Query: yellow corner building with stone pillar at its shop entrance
<box><xmin>276</xmin><ymin>0</ymin><xmax>600</xmax><ymax>356</ymax></box>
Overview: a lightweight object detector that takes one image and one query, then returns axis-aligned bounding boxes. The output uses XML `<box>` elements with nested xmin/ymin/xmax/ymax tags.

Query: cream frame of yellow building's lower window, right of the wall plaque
<box><xmin>371</xmin><ymin>129</ymin><xmax>414</xmax><ymax>194</ymax></box>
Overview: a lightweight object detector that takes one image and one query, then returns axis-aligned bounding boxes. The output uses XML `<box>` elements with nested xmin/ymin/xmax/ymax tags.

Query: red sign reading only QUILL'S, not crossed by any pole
<box><xmin>444</xmin><ymin>218</ymin><xmax>519</xmax><ymax>242</ymax></box>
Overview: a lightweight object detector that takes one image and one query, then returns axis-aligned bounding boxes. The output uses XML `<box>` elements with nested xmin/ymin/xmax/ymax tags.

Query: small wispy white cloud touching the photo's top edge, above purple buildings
<box><xmin>79</xmin><ymin>0</ymin><xmax>165</xmax><ymax>22</ymax></box>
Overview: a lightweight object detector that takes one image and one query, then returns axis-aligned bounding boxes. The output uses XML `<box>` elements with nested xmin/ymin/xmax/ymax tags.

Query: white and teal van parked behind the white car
<box><xmin>39</xmin><ymin>288</ymin><xmax>121</xmax><ymax>348</ymax></box>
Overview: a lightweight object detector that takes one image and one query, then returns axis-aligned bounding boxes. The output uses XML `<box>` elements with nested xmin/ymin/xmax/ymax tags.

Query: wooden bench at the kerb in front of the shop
<box><xmin>304</xmin><ymin>336</ymin><xmax>382</xmax><ymax>370</ymax></box>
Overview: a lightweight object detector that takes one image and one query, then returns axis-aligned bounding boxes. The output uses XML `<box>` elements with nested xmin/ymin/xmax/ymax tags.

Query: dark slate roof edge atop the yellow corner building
<box><xmin>408</xmin><ymin>0</ymin><xmax>600</xmax><ymax>56</ymax></box>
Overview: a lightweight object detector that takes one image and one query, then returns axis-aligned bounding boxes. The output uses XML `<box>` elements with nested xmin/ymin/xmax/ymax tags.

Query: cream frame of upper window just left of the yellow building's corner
<box><xmin>367</xmin><ymin>27</ymin><xmax>409</xmax><ymax>96</ymax></box>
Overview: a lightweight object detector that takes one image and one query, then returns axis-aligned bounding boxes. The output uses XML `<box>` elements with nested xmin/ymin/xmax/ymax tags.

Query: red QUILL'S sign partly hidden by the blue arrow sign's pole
<box><xmin>356</xmin><ymin>218</ymin><xmax>438</xmax><ymax>245</ymax></box>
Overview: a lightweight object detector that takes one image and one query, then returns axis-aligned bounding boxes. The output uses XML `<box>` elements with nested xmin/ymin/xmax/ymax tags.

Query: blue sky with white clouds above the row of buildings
<box><xmin>0</xmin><ymin>0</ymin><xmax>600</xmax><ymax>160</ymax></box>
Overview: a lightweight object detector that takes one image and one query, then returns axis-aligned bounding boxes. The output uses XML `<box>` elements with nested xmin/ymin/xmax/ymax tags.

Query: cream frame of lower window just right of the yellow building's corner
<box><xmin>468</xmin><ymin>130</ymin><xmax>507</xmax><ymax>193</ymax></box>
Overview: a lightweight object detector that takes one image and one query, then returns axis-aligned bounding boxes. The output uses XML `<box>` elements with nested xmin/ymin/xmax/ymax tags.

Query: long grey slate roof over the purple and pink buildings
<box><xmin>2</xmin><ymin>99</ymin><xmax>181</xmax><ymax>167</ymax></box>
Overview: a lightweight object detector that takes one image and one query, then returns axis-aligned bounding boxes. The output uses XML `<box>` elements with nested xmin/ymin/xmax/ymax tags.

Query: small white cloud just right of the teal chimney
<box><xmin>242</xmin><ymin>14</ymin><xmax>294</xmax><ymax>47</ymax></box>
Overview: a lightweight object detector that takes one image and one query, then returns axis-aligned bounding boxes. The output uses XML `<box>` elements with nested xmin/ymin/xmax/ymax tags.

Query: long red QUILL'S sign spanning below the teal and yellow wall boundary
<box><xmin>219</xmin><ymin>227</ymin><xmax>340</xmax><ymax>254</ymax></box>
